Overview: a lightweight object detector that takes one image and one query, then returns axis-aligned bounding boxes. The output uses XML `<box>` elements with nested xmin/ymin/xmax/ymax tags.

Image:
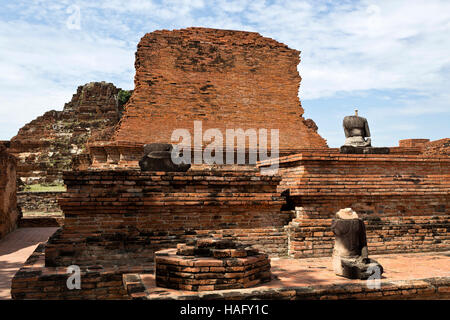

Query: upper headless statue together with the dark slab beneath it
<box><xmin>340</xmin><ymin>110</ymin><xmax>389</xmax><ymax>154</ymax></box>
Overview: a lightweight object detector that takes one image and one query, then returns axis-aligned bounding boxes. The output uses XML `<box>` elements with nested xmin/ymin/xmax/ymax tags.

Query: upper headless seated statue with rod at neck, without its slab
<box><xmin>342</xmin><ymin>110</ymin><xmax>371</xmax><ymax>147</ymax></box>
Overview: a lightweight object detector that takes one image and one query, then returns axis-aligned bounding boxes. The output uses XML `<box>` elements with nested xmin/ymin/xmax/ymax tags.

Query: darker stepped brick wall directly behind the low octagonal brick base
<box><xmin>45</xmin><ymin>170</ymin><xmax>292</xmax><ymax>266</ymax></box>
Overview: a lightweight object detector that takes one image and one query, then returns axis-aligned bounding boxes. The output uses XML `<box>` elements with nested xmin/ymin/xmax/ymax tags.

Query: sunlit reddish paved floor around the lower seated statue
<box><xmin>139</xmin><ymin>251</ymin><xmax>450</xmax><ymax>299</ymax></box>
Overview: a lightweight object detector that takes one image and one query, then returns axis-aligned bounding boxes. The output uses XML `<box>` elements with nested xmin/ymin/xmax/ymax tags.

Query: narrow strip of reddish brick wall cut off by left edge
<box><xmin>0</xmin><ymin>141</ymin><xmax>20</xmax><ymax>239</ymax></box>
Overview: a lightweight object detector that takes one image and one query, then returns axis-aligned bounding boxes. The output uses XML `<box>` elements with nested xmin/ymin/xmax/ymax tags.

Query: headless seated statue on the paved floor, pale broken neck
<box><xmin>331</xmin><ymin>208</ymin><xmax>383</xmax><ymax>279</ymax></box>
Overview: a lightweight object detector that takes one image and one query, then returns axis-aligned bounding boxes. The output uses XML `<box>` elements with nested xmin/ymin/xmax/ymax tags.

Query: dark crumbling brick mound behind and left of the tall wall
<box><xmin>9</xmin><ymin>82</ymin><xmax>122</xmax><ymax>185</ymax></box>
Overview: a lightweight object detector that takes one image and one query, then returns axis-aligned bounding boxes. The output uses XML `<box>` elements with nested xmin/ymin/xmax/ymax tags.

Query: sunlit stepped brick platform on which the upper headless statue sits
<box><xmin>260</xmin><ymin>151</ymin><xmax>450</xmax><ymax>258</ymax></box>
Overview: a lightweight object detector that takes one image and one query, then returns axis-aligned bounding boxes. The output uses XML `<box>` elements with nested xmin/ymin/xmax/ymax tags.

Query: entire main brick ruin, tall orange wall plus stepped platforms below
<box><xmin>11</xmin><ymin>28</ymin><xmax>450</xmax><ymax>299</ymax></box>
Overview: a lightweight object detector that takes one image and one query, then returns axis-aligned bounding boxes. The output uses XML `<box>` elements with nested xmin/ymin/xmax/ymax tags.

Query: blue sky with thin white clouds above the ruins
<box><xmin>0</xmin><ymin>0</ymin><xmax>450</xmax><ymax>147</ymax></box>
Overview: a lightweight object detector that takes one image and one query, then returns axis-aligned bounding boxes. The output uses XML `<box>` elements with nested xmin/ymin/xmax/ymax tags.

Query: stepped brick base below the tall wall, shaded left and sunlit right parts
<box><xmin>12</xmin><ymin>152</ymin><xmax>450</xmax><ymax>299</ymax></box>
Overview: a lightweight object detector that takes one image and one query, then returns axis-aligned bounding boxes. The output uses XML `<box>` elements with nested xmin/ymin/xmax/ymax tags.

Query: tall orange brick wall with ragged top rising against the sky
<box><xmin>114</xmin><ymin>28</ymin><xmax>326</xmax><ymax>149</ymax></box>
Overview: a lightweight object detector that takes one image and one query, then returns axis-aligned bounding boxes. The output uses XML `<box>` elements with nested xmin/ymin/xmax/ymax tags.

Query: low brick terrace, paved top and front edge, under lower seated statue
<box><xmin>124</xmin><ymin>252</ymin><xmax>450</xmax><ymax>300</ymax></box>
